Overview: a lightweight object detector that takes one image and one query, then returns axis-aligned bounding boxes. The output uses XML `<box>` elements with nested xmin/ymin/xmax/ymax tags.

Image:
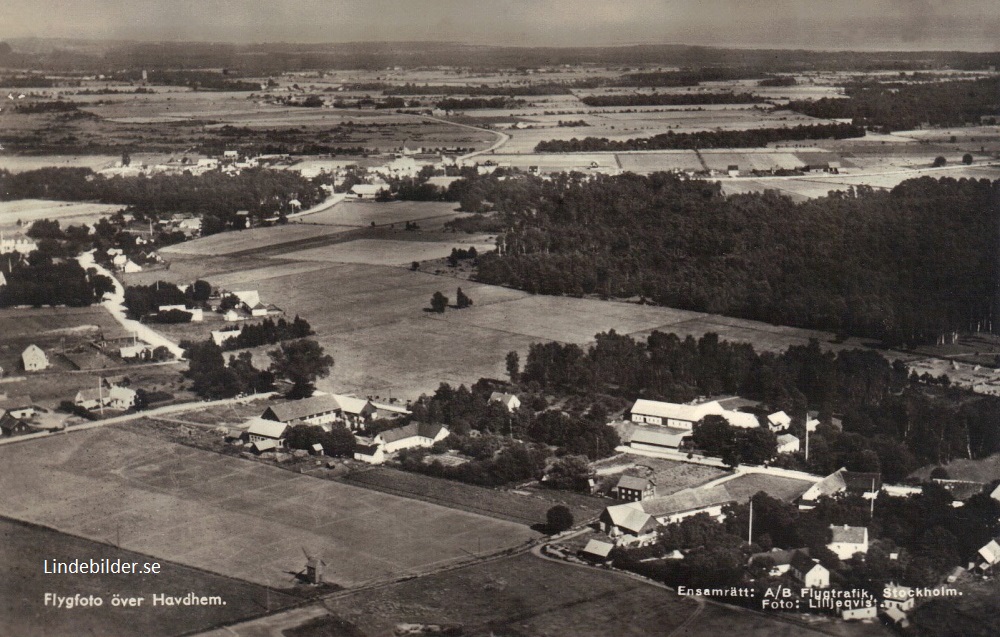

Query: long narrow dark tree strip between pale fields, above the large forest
<box><xmin>535</xmin><ymin>124</ymin><xmax>865</xmax><ymax>153</ymax></box>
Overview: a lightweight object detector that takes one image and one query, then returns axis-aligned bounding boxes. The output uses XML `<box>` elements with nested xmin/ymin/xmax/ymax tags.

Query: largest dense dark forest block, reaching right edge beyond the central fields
<box><xmin>458</xmin><ymin>173</ymin><xmax>1000</xmax><ymax>345</ymax></box>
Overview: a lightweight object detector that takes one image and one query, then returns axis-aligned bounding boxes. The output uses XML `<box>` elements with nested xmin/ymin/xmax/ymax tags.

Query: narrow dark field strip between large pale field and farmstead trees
<box><xmin>346</xmin><ymin>467</ymin><xmax>604</xmax><ymax>526</ymax></box>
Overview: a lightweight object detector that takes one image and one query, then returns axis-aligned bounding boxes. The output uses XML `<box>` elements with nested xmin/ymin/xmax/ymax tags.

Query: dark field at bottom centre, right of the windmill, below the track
<box><xmin>316</xmin><ymin>555</ymin><xmax>832</xmax><ymax>637</ymax></box>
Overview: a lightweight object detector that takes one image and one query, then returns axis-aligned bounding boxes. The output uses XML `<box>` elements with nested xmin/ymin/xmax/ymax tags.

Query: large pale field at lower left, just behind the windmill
<box><xmin>0</xmin><ymin>426</ymin><xmax>535</xmax><ymax>586</ymax></box>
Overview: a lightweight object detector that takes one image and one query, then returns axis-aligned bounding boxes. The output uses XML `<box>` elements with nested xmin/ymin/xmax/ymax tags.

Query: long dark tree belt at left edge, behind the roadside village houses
<box><xmin>0</xmin><ymin>168</ymin><xmax>325</xmax><ymax>230</ymax></box>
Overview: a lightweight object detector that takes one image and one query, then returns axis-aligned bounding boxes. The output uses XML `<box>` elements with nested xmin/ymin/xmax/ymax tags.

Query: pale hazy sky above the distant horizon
<box><xmin>0</xmin><ymin>0</ymin><xmax>1000</xmax><ymax>51</ymax></box>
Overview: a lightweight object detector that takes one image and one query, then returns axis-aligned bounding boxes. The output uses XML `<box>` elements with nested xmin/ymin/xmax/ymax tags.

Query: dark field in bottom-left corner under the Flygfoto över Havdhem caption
<box><xmin>0</xmin><ymin>519</ymin><xmax>296</xmax><ymax>637</ymax></box>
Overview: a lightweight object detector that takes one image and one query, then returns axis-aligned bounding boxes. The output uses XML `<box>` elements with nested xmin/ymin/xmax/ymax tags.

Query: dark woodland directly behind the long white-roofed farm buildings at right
<box><xmin>520</xmin><ymin>331</ymin><xmax>1000</xmax><ymax>482</ymax></box>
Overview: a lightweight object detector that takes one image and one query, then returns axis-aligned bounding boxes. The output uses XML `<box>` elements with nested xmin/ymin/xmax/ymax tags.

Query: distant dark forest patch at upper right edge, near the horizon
<box><xmin>783</xmin><ymin>77</ymin><xmax>1000</xmax><ymax>132</ymax></box>
